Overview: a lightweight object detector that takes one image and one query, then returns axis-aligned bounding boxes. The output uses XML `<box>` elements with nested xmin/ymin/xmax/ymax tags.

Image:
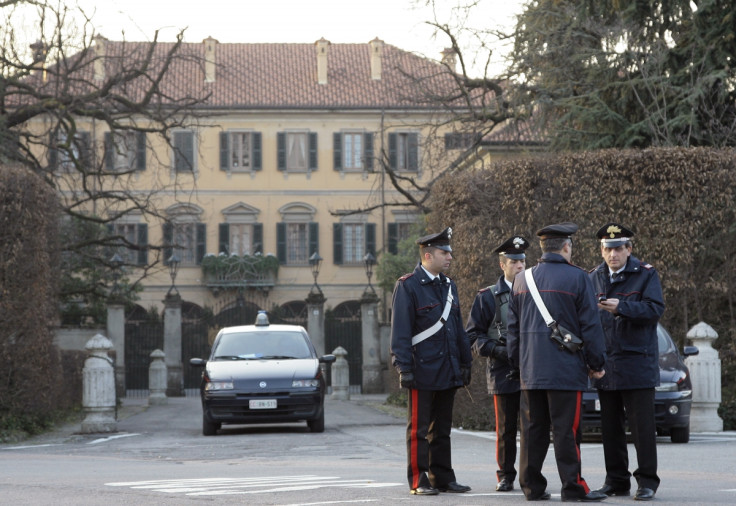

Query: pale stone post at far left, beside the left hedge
<box><xmin>81</xmin><ymin>334</ymin><xmax>118</xmax><ymax>433</ymax></box>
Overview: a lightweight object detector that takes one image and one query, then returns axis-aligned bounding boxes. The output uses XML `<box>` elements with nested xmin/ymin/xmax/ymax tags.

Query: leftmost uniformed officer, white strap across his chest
<box><xmin>391</xmin><ymin>228</ymin><xmax>472</xmax><ymax>495</ymax></box>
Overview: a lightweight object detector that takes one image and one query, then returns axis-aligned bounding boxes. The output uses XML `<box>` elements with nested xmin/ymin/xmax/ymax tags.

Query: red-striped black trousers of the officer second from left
<box><xmin>493</xmin><ymin>392</ymin><xmax>521</xmax><ymax>482</ymax></box>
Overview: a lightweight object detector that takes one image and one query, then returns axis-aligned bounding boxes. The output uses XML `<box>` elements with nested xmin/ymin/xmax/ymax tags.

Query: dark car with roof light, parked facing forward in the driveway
<box><xmin>189</xmin><ymin>311</ymin><xmax>335</xmax><ymax>436</ymax></box>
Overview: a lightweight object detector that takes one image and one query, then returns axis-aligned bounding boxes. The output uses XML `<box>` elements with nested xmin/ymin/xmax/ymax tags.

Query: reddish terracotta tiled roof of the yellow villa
<box><xmin>23</xmin><ymin>41</ymin><xmax>460</xmax><ymax>109</ymax></box>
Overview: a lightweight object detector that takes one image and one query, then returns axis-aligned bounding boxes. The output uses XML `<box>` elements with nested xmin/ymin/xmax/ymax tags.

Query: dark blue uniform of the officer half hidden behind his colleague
<box><xmin>465</xmin><ymin>276</ymin><xmax>521</xmax><ymax>484</ymax></box>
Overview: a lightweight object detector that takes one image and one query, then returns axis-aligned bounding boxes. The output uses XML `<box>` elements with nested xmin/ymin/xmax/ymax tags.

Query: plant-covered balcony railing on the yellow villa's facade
<box><xmin>202</xmin><ymin>253</ymin><xmax>279</xmax><ymax>288</ymax></box>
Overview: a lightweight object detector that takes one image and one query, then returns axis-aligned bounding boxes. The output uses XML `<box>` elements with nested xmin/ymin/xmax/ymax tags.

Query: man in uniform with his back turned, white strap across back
<box><xmin>507</xmin><ymin>222</ymin><xmax>607</xmax><ymax>501</ymax></box>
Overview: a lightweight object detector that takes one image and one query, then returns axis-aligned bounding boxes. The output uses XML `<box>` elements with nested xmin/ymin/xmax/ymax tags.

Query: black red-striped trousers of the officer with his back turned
<box><xmin>519</xmin><ymin>390</ymin><xmax>590</xmax><ymax>499</ymax></box>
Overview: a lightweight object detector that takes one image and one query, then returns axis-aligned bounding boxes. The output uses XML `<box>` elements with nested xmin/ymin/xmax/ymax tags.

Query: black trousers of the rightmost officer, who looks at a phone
<box><xmin>598</xmin><ymin>388</ymin><xmax>659</xmax><ymax>491</ymax></box>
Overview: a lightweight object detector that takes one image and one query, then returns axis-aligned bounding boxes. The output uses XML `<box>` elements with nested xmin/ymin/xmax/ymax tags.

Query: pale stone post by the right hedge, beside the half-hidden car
<box><xmin>685</xmin><ymin>322</ymin><xmax>723</xmax><ymax>432</ymax></box>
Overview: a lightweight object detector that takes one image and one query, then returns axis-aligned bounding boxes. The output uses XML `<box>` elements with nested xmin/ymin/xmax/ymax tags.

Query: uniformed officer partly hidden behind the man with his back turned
<box><xmin>465</xmin><ymin>235</ymin><xmax>529</xmax><ymax>492</ymax></box>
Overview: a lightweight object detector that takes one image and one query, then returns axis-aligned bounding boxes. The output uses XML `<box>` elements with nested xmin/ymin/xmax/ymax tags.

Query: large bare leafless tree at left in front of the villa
<box><xmin>0</xmin><ymin>0</ymin><xmax>208</xmax><ymax>322</ymax></box>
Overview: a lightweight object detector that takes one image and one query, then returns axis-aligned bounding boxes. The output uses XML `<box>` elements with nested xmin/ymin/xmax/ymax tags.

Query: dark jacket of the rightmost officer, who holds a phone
<box><xmin>590</xmin><ymin>256</ymin><xmax>664</xmax><ymax>390</ymax></box>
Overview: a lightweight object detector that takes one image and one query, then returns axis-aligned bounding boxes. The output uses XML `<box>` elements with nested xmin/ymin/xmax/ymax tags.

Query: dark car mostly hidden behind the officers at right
<box><xmin>583</xmin><ymin>325</ymin><xmax>698</xmax><ymax>443</ymax></box>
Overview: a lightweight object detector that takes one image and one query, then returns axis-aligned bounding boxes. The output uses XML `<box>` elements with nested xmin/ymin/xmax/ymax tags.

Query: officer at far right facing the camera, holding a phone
<box><xmin>590</xmin><ymin>223</ymin><xmax>664</xmax><ymax>501</ymax></box>
